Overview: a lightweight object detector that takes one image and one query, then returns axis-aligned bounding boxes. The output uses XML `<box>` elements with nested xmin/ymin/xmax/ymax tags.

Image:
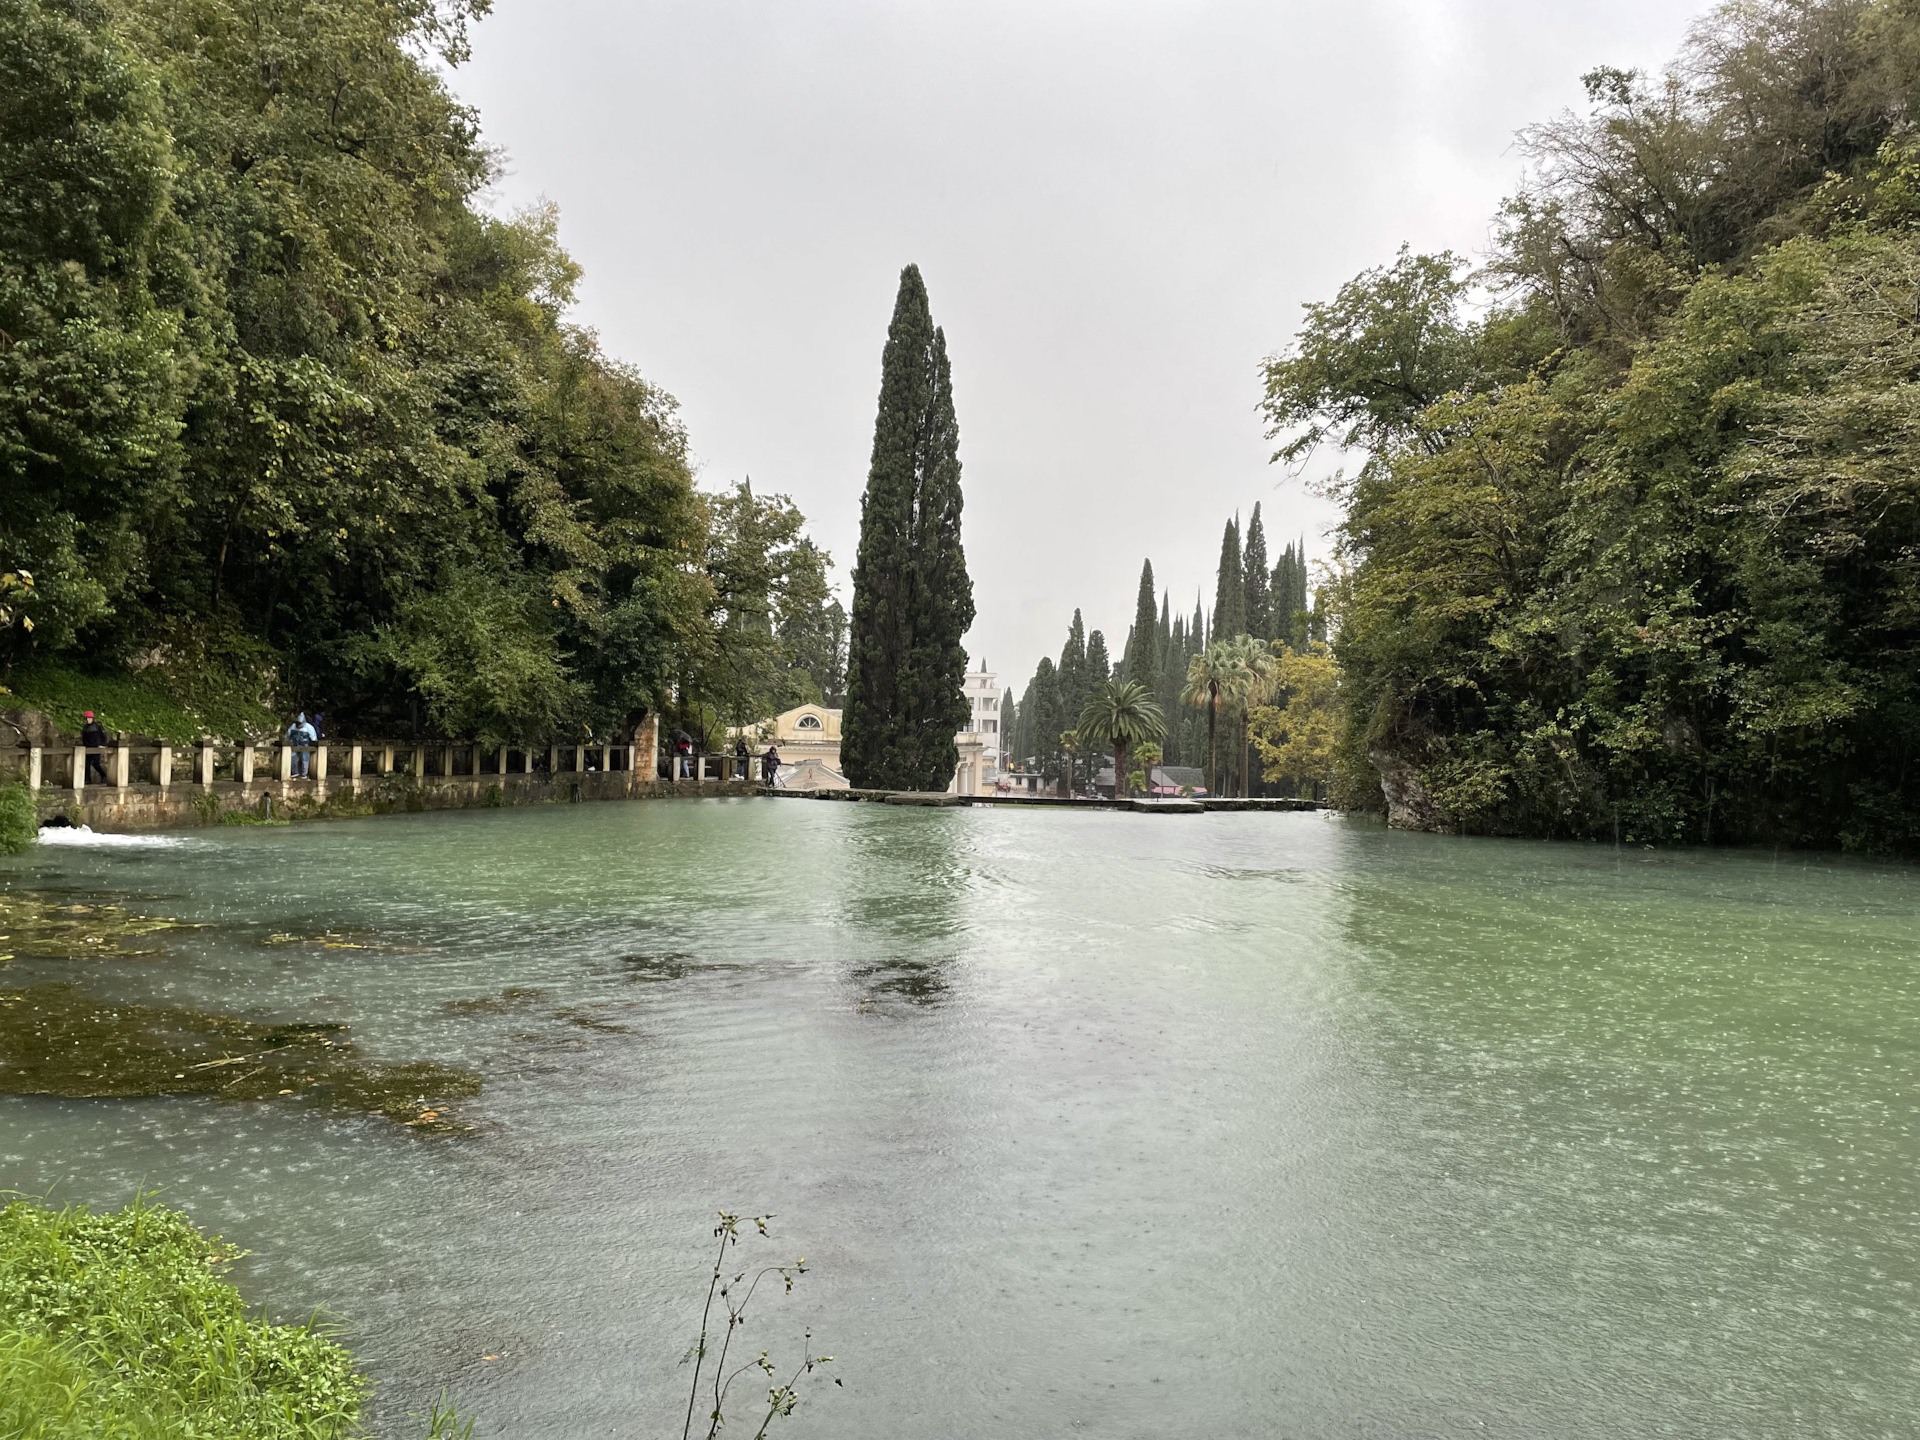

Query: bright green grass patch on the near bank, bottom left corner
<box><xmin>0</xmin><ymin>1198</ymin><xmax>367</xmax><ymax>1440</ymax></box>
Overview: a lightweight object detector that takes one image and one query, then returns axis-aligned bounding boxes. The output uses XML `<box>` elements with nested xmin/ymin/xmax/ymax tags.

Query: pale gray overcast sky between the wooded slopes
<box><xmin>455</xmin><ymin>0</ymin><xmax>1703</xmax><ymax>684</ymax></box>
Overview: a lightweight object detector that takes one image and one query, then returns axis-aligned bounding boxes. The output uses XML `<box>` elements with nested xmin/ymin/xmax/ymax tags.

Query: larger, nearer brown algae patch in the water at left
<box><xmin>0</xmin><ymin>983</ymin><xmax>480</xmax><ymax>1131</ymax></box>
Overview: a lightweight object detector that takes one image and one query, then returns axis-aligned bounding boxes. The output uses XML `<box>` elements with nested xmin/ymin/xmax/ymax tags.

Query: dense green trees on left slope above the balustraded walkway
<box><xmin>0</xmin><ymin>0</ymin><xmax>708</xmax><ymax>735</ymax></box>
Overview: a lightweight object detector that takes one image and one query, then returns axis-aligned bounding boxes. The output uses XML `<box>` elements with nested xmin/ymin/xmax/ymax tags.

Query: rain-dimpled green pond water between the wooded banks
<box><xmin>0</xmin><ymin>801</ymin><xmax>1920</xmax><ymax>1440</ymax></box>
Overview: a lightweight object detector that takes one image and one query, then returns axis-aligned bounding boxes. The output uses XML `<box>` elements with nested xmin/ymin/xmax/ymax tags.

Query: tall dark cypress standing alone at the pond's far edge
<box><xmin>841</xmin><ymin>265</ymin><xmax>973</xmax><ymax>791</ymax></box>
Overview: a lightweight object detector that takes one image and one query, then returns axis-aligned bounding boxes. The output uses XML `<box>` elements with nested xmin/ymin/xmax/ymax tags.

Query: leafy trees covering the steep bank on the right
<box><xmin>1267</xmin><ymin>0</ymin><xmax>1920</xmax><ymax>851</ymax></box>
